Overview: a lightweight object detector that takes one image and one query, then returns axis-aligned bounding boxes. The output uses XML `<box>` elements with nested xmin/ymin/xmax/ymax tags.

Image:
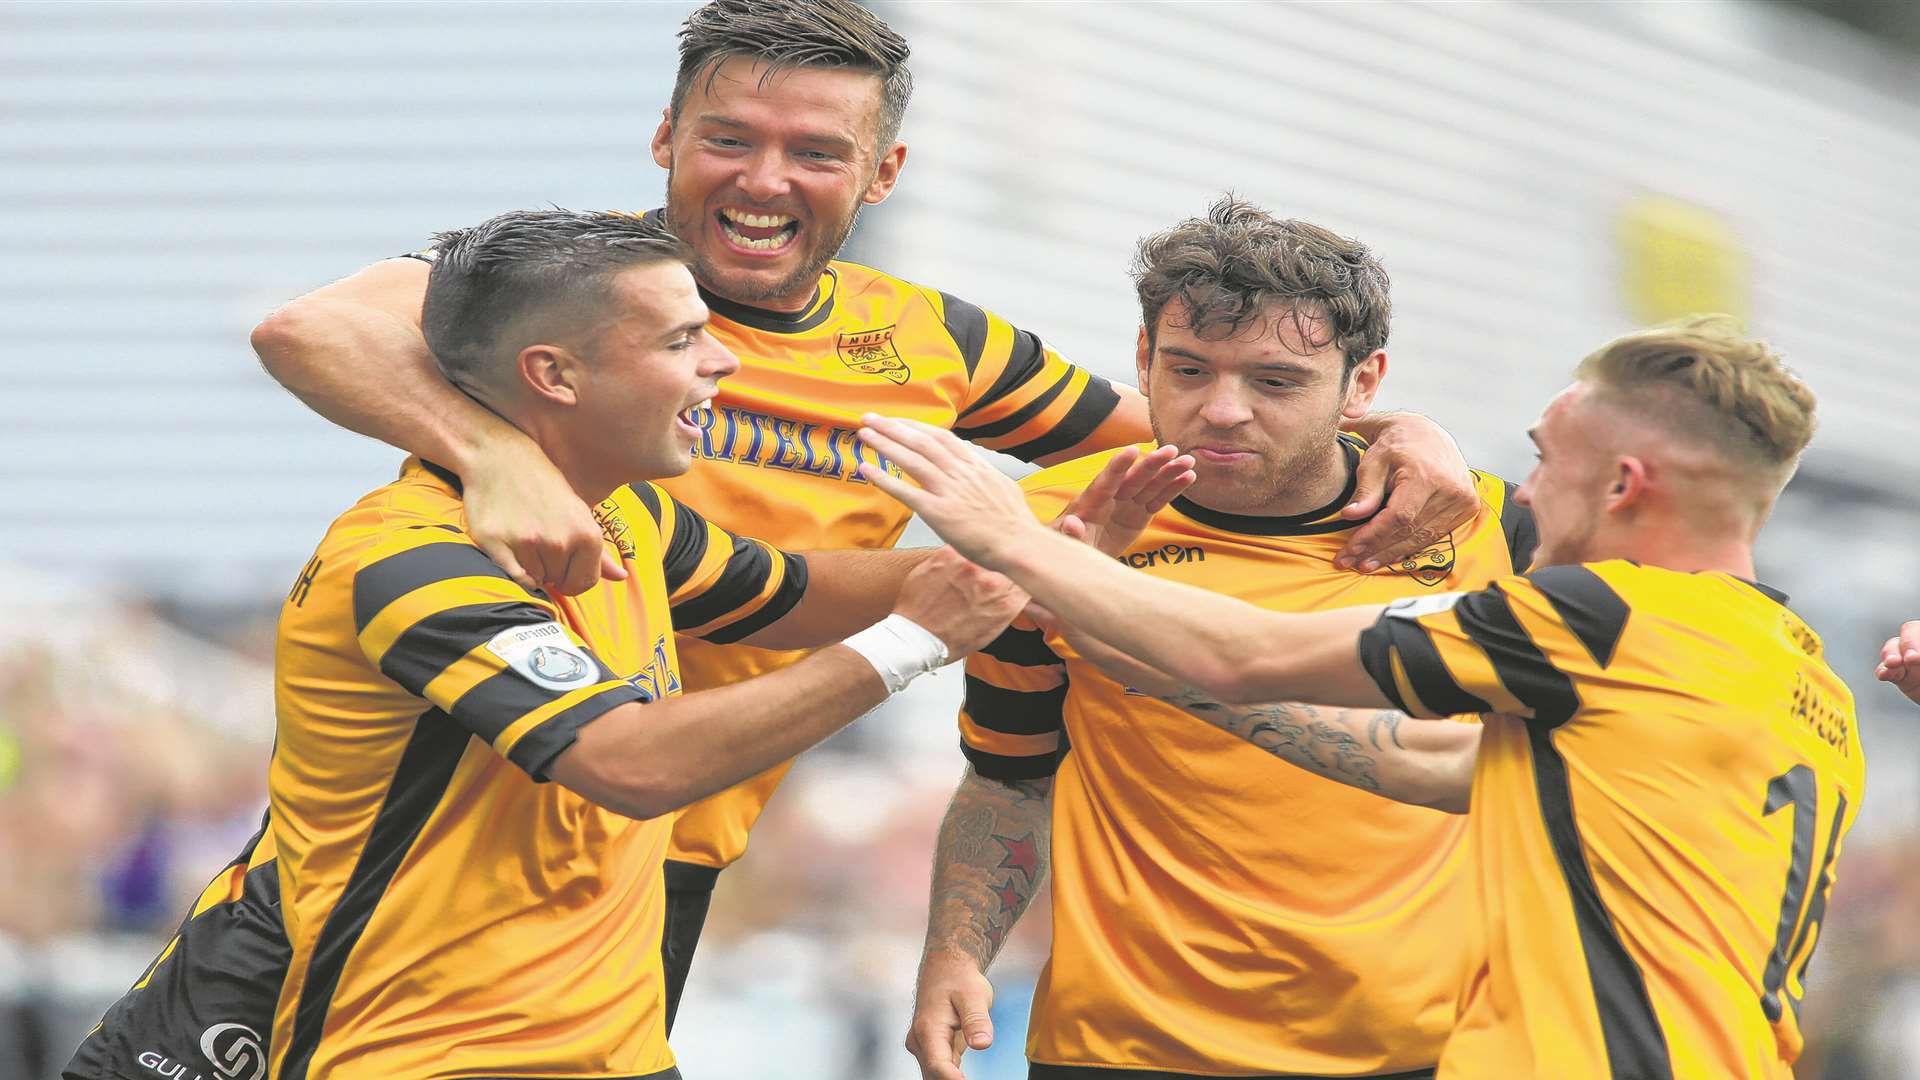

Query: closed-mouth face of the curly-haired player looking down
<box><xmin>1137</xmin><ymin>300</ymin><xmax>1386</xmax><ymax>515</ymax></box>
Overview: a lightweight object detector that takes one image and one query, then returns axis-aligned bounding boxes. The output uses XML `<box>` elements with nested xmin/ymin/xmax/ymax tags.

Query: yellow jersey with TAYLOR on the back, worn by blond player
<box><xmin>1361</xmin><ymin>561</ymin><xmax>1866</xmax><ymax>1080</ymax></box>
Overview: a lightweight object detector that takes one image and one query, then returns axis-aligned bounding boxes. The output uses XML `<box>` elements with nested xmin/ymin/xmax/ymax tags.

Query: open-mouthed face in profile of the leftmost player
<box><xmin>566</xmin><ymin>261</ymin><xmax>739</xmax><ymax>480</ymax></box>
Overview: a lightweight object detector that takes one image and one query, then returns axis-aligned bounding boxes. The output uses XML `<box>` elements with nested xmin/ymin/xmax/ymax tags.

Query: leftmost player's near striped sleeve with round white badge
<box><xmin>353</xmin><ymin>536</ymin><xmax>641</xmax><ymax>780</ymax></box>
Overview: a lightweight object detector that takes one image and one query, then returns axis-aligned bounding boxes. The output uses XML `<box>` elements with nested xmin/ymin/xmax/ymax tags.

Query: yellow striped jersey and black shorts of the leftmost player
<box><xmin>76</xmin><ymin>461</ymin><xmax>806</xmax><ymax>1080</ymax></box>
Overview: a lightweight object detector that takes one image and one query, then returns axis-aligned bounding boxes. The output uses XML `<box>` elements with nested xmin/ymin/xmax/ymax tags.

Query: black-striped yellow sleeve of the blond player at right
<box><xmin>1359</xmin><ymin>567</ymin><xmax>1628</xmax><ymax>728</ymax></box>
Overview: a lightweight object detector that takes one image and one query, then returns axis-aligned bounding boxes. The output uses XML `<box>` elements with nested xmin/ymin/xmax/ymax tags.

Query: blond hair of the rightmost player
<box><xmin>1574</xmin><ymin>315</ymin><xmax>1814</xmax><ymax>469</ymax></box>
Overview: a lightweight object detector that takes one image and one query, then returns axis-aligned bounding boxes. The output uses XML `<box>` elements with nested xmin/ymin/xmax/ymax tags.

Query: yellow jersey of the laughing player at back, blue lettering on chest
<box><xmin>401</xmin><ymin>231</ymin><xmax>1139</xmax><ymax>869</ymax></box>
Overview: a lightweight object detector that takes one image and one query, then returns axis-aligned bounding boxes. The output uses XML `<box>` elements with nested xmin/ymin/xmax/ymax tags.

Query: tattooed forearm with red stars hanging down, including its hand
<box><xmin>906</xmin><ymin>767</ymin><xmax>1054</xmax><ymax>1080</ymax></box>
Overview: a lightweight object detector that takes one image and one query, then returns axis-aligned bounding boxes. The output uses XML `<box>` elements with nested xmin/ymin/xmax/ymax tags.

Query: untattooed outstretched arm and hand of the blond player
<box><xmin>860</xmin><ymin>417</ymin><xmax>1390</xmax><ymax>707</ymax></box>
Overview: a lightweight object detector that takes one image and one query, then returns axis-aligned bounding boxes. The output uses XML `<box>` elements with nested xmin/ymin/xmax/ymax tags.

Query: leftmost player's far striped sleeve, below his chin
<box><xmin>634</xmin><ymin>484</ymin><xmax>806</xmax><ymax>644</ymax></box>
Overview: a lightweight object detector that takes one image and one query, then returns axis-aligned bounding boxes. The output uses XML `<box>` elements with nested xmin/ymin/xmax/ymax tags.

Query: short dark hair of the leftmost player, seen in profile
<box><xmin>420</xmin><ymin>209</ymin><xmax>693</xmax><ymax>390</ymax></box>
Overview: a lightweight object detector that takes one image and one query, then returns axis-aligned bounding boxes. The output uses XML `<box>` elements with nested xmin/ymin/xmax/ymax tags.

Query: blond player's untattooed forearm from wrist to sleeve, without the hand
<box><xmin>993</xmin><ymin>527</ymin><xmax>1388</xmax><ymax>705</ymax></box>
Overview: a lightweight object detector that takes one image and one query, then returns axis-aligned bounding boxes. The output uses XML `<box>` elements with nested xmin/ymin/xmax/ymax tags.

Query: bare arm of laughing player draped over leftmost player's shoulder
<box><xmin>253</xmin><ymin>259</ymin><xmax>606</xmax><ymax>594</ymax></box>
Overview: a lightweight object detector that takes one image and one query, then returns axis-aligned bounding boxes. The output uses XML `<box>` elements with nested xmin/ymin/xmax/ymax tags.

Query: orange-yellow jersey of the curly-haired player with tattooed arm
<box><xmin>960</xmin><ymin>440</ymin><xmax>1532</xmax><ymax>1078</ymax></box>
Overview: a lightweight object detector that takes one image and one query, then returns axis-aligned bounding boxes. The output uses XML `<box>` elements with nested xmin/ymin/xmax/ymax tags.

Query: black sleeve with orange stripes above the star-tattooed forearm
<box><xmin>960</xmin><ymin>626</ymin><xmax>1068</xmax><ymax>780</ymax></box>
